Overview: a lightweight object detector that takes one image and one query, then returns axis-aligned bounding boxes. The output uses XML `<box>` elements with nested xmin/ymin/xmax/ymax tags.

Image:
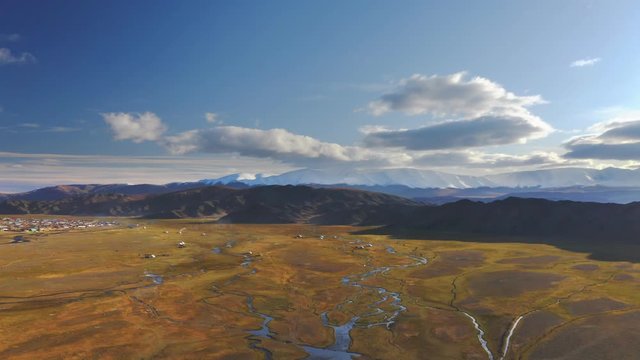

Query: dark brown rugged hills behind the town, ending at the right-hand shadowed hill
<box><xmin>0</xmin><ymin>186</ymin><xmax>420</xmax><ymax>225</ymax></box>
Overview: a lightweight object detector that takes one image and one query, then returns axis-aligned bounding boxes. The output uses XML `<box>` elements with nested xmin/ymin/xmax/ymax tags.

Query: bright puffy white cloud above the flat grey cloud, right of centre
<box><xmin>368</xmin><ymin>72</ymin><xmax>545</xmax><ymax>118</ymax></box>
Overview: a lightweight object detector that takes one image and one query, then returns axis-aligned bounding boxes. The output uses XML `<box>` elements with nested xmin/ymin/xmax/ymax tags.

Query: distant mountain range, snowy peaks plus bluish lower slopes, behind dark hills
<box><xmin>6</xmin><ymin>168</ymin><xmax>640</xmax><ymax>204</ymax></box>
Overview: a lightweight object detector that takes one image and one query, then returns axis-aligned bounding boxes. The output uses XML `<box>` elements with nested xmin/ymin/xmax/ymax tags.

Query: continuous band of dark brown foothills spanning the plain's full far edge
<box><xmin>0</xmin><ymin>185</ymin><xmax>640</xmax><ymax>250</ymax></box>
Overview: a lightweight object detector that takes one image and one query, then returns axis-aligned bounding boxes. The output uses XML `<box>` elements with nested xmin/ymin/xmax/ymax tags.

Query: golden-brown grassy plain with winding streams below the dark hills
<box><xmin>0</xmin><ymin>219</ymin><xmax>640</xmax><ymax>359</ymax></box>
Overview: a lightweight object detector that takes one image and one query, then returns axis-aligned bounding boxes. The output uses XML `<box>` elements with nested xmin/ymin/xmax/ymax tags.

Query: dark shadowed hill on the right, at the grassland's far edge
<box><xmin>395</xmin><ymin>198</ymin><xmax>640</xmax><ymax>241</ymax></box>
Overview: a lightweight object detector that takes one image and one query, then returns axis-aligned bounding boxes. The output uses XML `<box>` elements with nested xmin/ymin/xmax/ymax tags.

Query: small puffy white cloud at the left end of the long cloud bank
<box><xmin>101</xmin><ymin>112</ymin><xmax>167</xmax><ymax>143</ymax></box>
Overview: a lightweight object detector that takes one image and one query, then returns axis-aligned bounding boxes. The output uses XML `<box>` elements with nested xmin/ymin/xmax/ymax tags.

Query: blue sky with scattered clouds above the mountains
<box><xmin>0</xmin><ymin>0</ymin><xmax>640</xmax><ymax>192</ymax></box>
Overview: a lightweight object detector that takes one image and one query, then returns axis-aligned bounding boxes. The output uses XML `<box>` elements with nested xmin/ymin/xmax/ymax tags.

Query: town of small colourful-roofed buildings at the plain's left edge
<box><xmin>0</xmin><ymin>217</ymin><xmax>118</xmax><ymax>232</ymax></box>
